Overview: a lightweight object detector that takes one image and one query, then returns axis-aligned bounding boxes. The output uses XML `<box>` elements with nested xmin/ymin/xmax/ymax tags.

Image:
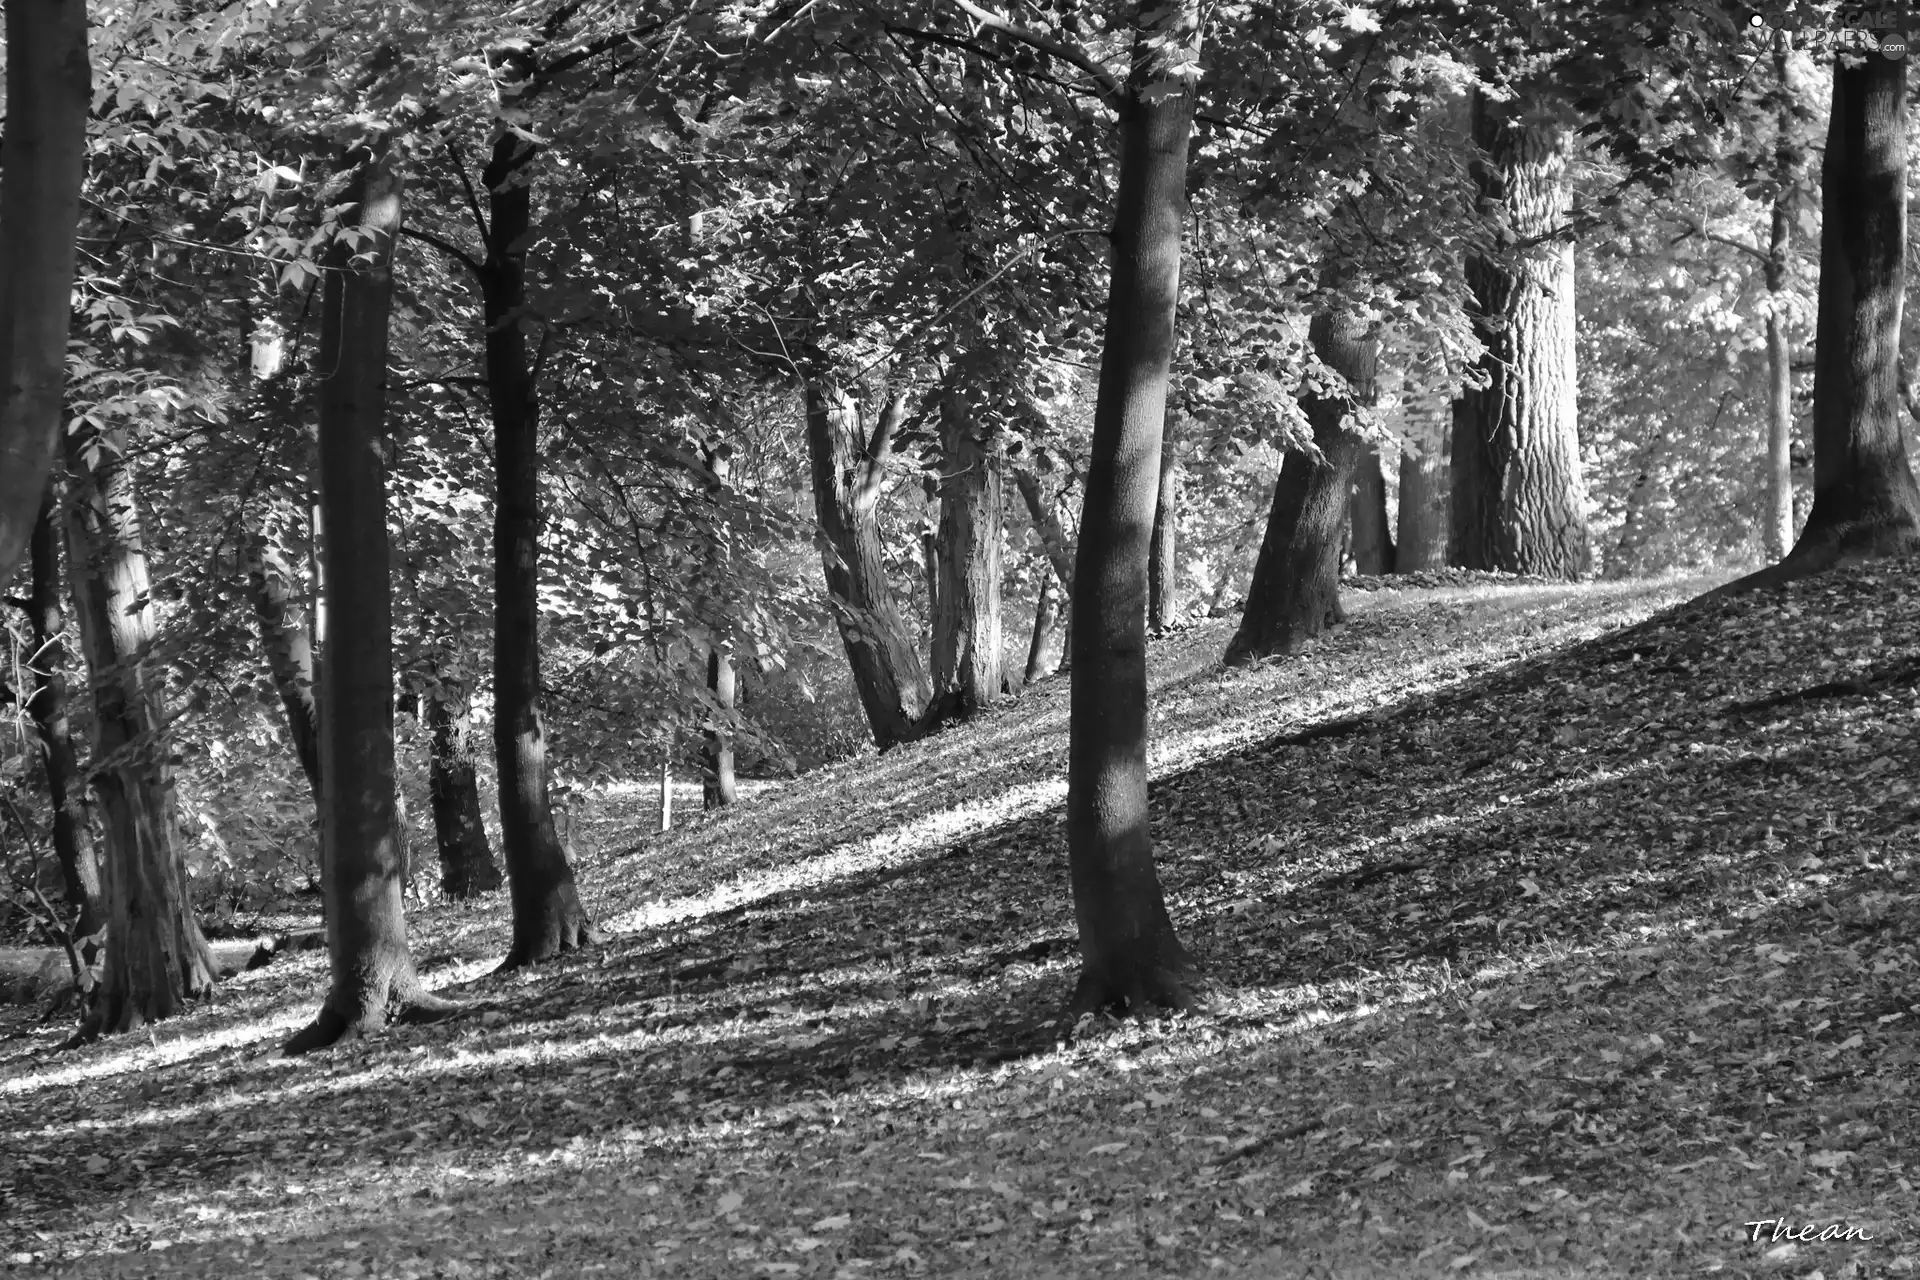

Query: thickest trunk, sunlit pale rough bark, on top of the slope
<box><xmin>1453</xmin><ymin>94</ymin><xmax>1592</xmax><ymax>578</ymax></box>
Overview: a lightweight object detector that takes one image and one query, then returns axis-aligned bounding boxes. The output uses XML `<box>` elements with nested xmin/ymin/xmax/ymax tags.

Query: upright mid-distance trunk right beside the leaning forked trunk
<box><xmin>933</xmin><ymin>388</ymin><xmax>1006</xmax><ymax>718</ymax></box>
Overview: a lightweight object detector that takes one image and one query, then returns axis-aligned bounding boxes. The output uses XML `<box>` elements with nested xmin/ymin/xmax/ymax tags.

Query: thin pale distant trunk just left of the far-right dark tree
<box><xmin>1761</xmin><ymin>29</ymin><xmax>1803</xmax><ymax>560</ymax></box>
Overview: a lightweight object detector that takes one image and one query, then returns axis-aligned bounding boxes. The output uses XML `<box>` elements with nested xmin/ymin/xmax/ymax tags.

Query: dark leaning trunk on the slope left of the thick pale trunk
<box><xmin>1227</xmin><ymin>315</ymin><xmax>1379</xmax><ymax>664</ymax></box>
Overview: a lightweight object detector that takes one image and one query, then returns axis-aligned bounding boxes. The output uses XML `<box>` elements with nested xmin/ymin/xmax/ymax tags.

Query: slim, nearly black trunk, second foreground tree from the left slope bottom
<box><xmin>480</xmin><ymin>129</ymin><xmax>593</xmax><ymax>969</ymax></box>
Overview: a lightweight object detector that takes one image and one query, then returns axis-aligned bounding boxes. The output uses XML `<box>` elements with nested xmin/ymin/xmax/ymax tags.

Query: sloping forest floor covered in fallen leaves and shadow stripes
<box><xmin>0</xmin><ymin>562</ymin><xmax>1920</xmax><ymax>1280</ymax></box>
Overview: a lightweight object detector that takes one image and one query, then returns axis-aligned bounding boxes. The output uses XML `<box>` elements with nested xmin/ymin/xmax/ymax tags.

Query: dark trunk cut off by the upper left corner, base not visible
<box><xmin>0</xmin><ymin>0</ymin><xmax>92</xmax><ymax>585</ymax></box>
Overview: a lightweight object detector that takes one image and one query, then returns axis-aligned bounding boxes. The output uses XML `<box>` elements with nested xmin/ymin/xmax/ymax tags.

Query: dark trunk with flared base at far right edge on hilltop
<box><xmin>1713</xmin><ymin>56</ymin><xmax>1920</xmax><ymax>595</ymax></box>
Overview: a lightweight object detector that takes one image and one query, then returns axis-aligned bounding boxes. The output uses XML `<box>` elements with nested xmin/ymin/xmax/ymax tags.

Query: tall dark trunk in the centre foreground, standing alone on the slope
<box><xmin>1068</xmin><ymin>0</ymin><xmax>1200</xmax><ymax>1013</ymax></box>
